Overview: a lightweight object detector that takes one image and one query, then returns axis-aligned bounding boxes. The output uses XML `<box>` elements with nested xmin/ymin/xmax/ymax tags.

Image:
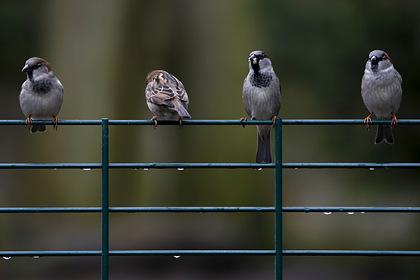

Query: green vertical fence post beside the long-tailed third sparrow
<box><xmin>275</xmin><ymin>118</ymin><xmax>283</xmax><ymax>280</ymax></box>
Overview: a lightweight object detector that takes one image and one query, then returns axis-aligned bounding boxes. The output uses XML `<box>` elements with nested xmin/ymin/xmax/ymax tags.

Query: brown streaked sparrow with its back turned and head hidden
<box><xmin>145</xmin><ymin>70</ymin><xmax>191</xmax><ymax>126</ymax></box>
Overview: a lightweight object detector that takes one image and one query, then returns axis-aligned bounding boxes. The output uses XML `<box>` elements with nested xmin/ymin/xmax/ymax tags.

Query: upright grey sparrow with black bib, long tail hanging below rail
<box><xmin>242</xmin><ymin>51</ymin><xmax>281</xmax><ymax>163</ymax></box>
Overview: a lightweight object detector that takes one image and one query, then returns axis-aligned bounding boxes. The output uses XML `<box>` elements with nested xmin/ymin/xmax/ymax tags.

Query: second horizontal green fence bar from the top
<box><xmin>0</xmin><ymin>162</ymin><xmax>420</xmax><ymax>170</ymax></box>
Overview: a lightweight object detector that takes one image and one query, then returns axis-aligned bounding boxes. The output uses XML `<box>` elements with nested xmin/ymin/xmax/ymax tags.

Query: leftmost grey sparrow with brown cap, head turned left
<box><xmin>19</xmin><ymin>57</ymin><xmax>64</xmax><ymax>133</ymax></box>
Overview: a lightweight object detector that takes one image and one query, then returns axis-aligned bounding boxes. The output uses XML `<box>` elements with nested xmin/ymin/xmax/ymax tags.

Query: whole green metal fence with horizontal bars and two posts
<box><xmin>0</xmin><ymin>119</ymin><xmax>420</xmax><ymax>280</ymax></box>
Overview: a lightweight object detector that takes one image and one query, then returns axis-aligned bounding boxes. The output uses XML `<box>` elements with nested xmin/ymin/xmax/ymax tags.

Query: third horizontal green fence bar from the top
<box><xmin>0</xmin><ymin>206</ymin><xmax>420</xmax><ymax>213</ymax></box>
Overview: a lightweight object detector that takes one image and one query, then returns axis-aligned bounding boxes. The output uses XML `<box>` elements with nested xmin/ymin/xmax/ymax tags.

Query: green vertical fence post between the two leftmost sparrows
<box><xmin>101</xmin><ymin>119</ymin><xmax>109</xmax><ymax>280</ymax></box>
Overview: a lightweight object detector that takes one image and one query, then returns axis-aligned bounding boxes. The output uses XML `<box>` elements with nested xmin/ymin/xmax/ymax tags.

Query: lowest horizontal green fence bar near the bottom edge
<box><xmin>0</xmin><ymin>250</ymin><xmax>420</xmax><ymax>259</ymax></box>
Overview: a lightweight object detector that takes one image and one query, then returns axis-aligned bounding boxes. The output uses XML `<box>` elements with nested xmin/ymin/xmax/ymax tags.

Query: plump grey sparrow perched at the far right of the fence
<box><xmin>362</xmin><ymin>50</ymin><xmax>402</xmax><ymax>144</ymax></box>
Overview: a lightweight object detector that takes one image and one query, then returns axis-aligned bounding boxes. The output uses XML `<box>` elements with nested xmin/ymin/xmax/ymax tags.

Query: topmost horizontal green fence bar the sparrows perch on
<box><xmin>0</xmin><ymin>119</ymin><xmax>420</xmax><ymax>126</ymax></box>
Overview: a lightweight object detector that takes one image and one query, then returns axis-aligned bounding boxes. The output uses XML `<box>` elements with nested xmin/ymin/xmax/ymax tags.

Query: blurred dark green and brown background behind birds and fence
<box><xmin>0</xmin><ymin>0</ymin><xmax>420</xmax><ymax>280</ymax></box>
